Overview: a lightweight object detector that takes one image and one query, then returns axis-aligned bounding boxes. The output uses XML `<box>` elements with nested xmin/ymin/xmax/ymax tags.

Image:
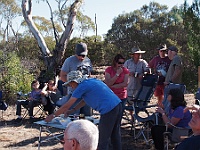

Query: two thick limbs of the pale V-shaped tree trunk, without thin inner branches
<box><xmin>21</xmin><ymin>0</ymin><xmax>82</xmax><ymax>77</ymax></box>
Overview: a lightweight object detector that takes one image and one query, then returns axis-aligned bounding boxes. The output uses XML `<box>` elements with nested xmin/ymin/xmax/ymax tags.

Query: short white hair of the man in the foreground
<box><xmin>65</xmin><ymin>119</ymin><xmax>99</xmax><ymax>150</ymax></box>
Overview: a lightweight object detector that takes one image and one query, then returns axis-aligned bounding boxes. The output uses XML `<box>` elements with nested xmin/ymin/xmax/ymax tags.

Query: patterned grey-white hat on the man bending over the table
<box><xmin>63</xmin><ymin>70</ymin><xmax>88</xmax><ymax>86</ymax></box>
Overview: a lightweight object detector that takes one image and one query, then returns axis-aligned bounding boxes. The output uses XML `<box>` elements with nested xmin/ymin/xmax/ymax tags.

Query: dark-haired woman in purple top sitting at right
<box><xmin>151</xmin><ymin>89</ymin><xmax>191</xmax><ymax>150</ymax></box>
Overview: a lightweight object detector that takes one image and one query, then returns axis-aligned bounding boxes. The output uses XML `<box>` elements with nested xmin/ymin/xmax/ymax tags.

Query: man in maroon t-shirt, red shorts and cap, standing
<box><xmin>149</xmin><ymin>44</ymin><xmax>171</xmax><ymax>106</ymax></box>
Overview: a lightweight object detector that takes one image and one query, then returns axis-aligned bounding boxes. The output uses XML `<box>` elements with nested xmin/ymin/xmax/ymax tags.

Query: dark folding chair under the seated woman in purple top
<box><xmin>163</xmin><ymin>123</ymin><xmax>192</xmax><ymax>150</ymax></box>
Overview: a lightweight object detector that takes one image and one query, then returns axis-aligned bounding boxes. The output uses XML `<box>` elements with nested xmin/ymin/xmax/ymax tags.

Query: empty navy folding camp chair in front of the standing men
<box><xmin>125</xmin><ymin>74</ymin><xmax>158</xmax><ymax>144</ymax></box>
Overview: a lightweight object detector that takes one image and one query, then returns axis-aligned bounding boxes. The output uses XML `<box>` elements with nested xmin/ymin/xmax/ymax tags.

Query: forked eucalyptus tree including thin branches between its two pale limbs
<box><xmin>21</xmin><ymin>0</ymin><xmax>94</xmax><ymax>79</ymax></box>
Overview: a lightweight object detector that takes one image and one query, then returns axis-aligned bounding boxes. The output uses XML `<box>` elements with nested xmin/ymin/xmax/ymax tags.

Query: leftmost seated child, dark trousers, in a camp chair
<box><xmin>15</xmin><ymin>80</ymin><xmax>41</xmax><ymax>122</ymax></box>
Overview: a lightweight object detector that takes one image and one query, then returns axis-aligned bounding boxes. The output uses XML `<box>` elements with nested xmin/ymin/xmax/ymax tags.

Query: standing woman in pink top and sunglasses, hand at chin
<box><xmin>105</xmin><ymin>54</ymin><xmax>129</xmax><ymax>107</ymax></box>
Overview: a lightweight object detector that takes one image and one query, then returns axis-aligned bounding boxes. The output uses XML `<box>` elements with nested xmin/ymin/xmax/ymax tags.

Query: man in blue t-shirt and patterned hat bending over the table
<box><xmin>45</xmin><ymin>71</ymin><xmax>122</xmax><ymax>150</ymax></box>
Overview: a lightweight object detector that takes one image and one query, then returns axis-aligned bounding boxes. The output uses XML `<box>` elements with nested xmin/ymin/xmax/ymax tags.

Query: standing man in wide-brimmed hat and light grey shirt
<box><xmin>124</xmin><ymin>47</ymin><xmax>149</xmax><ymax>98</ymax></box>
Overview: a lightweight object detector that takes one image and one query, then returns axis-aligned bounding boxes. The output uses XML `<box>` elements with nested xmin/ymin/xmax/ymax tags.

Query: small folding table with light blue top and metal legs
<box><xmin>34</xmin><ymin>116</ymin><xmax>99</xmax><ymax>150</ymax></box>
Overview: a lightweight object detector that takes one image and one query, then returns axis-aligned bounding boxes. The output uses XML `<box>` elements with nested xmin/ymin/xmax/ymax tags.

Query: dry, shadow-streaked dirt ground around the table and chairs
<box><xmin>0</xmin><ymin>94</ymin><xmax>194</xmax><ymax>150</ymax></box>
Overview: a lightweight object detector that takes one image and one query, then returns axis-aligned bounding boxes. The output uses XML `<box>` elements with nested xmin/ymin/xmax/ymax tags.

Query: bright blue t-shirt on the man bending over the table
<box><xmin>72</xmin><ymin>78</ymin><xmax>121</xmax><ymax>114</ymax></box>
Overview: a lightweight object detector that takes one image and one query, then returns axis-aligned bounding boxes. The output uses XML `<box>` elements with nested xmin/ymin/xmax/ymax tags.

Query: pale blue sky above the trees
<box><xmin>32</xmin><ymin>0</ymin><xmax>192</xmax><ymax>35</ymax></box>
